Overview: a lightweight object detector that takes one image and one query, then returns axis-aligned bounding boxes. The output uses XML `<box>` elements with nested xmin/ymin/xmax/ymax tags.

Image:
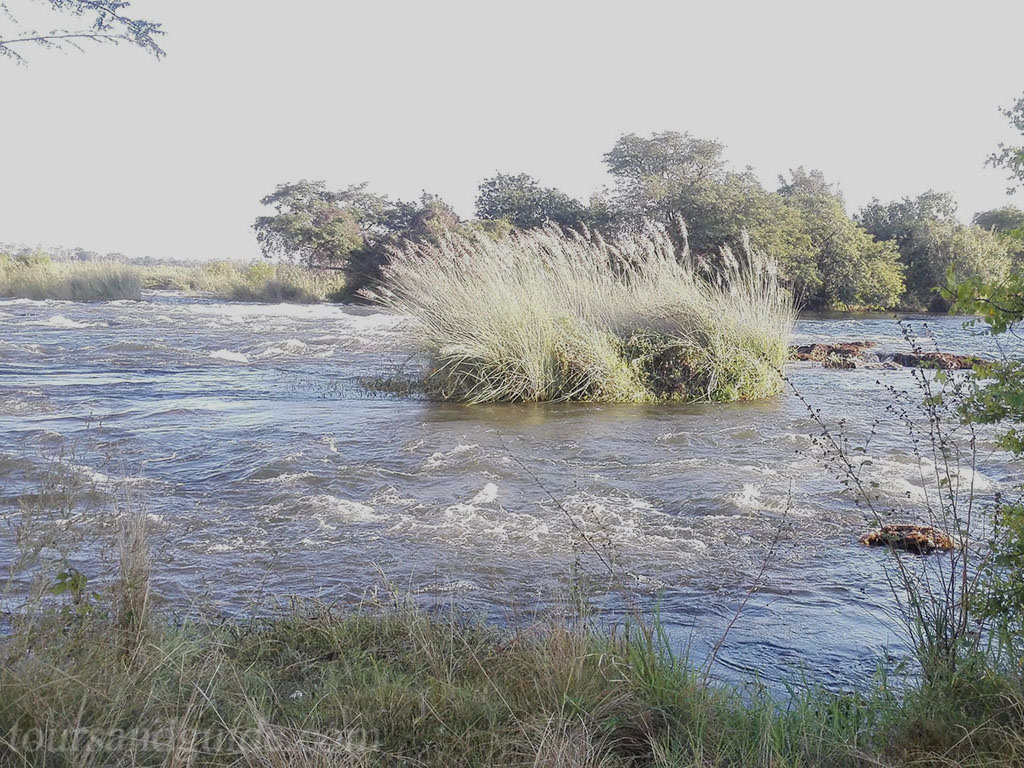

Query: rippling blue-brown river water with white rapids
<box><xmin>0</xmin><ymin>293</ymin><xmax>1015</xmax><ymax>686</ymax></box>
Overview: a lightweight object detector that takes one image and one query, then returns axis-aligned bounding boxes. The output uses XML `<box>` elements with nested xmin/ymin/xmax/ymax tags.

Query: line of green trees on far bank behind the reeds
<box><xmin>254</xmin><ymin>120</ymin><xmax>1024</xmax><ymax>310</ymax></box>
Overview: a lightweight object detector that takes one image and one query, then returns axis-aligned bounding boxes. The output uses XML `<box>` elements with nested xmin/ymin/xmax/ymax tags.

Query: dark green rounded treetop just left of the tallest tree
<box><xmin>476</xmin><ymin>173</ymin><xmax>589</xmax><ymax>229</ymax></box>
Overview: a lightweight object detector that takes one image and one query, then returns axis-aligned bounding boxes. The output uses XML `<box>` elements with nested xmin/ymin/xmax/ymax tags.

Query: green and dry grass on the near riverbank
<box><xmin>0</xmin><ymin>603</ymin><xmax>1024</xmax><ymax>768</ymax></box>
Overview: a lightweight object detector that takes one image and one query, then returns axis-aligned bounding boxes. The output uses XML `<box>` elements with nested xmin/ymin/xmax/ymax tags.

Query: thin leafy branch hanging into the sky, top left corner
<box><xmin>0</xmin><ymin>0</ymin><xmax>164</xmax><ymax>63</ymax></box>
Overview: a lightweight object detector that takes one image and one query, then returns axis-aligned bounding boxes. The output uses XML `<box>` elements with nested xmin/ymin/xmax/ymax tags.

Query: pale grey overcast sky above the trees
<box><xmin>0</xmin><ymin>0</ymin><xmax>1024</xmax><ymax>258</ymax></box>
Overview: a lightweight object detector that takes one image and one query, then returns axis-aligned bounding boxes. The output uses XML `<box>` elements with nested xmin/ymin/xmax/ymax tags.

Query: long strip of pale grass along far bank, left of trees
<box><xmin>0</xmin><ymin>254</ymin><xmax>345</xmax><ymax>303</ymax></box>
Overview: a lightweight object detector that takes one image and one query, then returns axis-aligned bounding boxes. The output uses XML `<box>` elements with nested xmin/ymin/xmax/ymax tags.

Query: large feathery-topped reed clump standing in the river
<box><xmin>365</xmin><ymin>224</ymin><xmax>796</xmax><ymax>402</ymax></box>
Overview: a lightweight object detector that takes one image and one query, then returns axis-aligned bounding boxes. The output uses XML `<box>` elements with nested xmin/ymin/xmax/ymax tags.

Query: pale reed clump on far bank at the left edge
<box><xmin>0</xmin><ymin>255</ymin><xmax>142</xmax><ymax>301</ymax></box>
